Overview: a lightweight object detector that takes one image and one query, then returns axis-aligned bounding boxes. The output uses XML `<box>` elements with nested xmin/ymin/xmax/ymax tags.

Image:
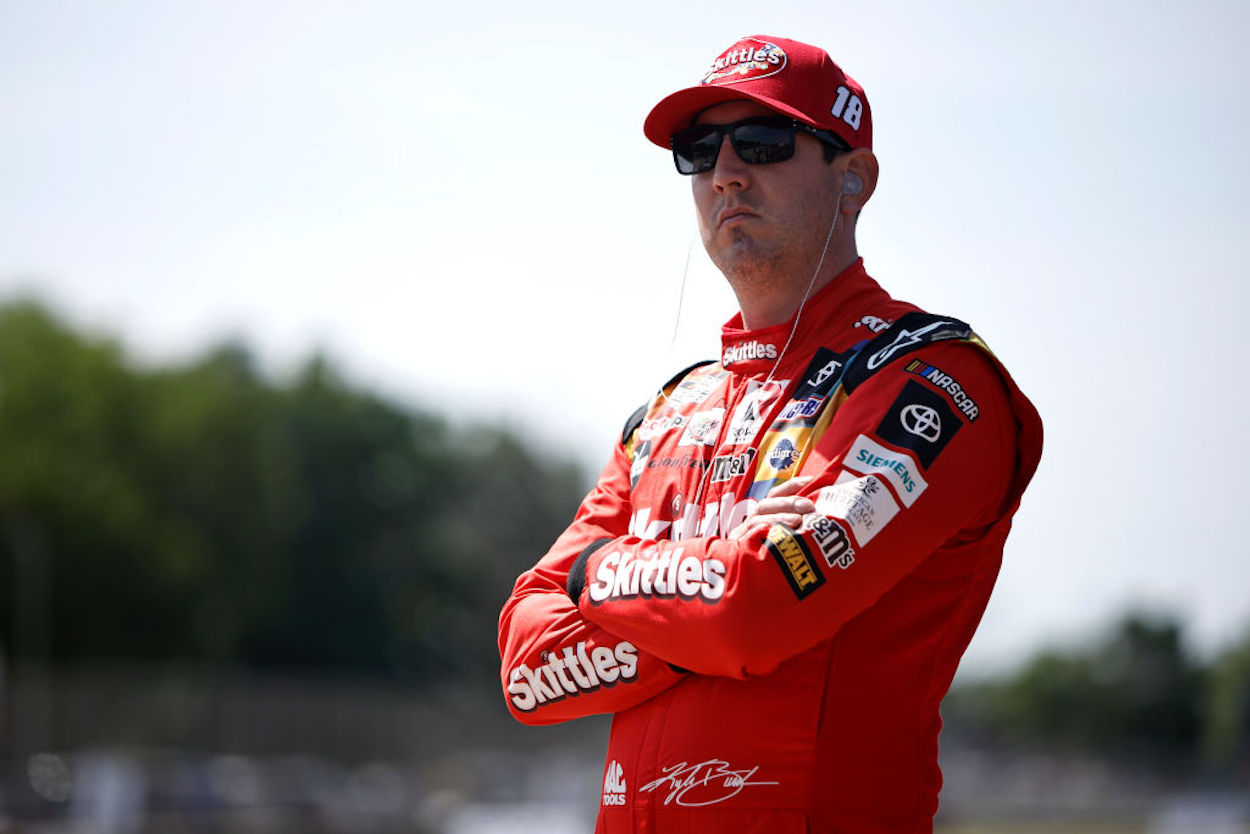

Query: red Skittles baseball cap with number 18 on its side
<box><xmin>643</xmin><ymin>35</ymin><xmax>873</xmax><ymax>148</ymax></box>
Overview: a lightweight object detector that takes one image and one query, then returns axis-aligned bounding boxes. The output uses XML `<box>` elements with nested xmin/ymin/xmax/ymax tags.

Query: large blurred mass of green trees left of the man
<box><xmin>0</xmin><ymin>303</ymin><xmax>584</xmax><ymax>683</ymax></box>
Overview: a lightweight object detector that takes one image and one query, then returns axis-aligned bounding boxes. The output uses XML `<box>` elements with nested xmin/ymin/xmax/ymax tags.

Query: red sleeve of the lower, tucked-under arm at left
<box><xmin>499</xmin><ymin>446</ymin><xmax>685</xmax><ymax>724</ymax></box>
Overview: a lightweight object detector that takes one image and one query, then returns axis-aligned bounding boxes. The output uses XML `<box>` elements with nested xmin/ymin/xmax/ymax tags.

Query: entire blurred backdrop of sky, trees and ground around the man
<box><xmin>0</xmin><ymin>0</ymin><xmax>1250</xmax><ymax>834</ymax></box>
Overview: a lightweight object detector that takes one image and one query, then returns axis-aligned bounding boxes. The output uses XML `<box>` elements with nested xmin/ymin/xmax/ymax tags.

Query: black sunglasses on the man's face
<box><xmin>669</xmin><ymin>116</ymin><xmax>850</xmax><ymax>174</ymax></box>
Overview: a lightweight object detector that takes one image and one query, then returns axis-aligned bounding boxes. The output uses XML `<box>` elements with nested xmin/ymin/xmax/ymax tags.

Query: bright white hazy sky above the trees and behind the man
<box><xmin>0</xmin><ymin>0</ymin><xmax>1250</xmax><ymax>670</ymax></box>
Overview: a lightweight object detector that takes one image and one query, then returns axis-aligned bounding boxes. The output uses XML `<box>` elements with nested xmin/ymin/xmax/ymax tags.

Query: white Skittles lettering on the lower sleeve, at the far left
<box><xmin>508</xmin><ymin>640</ymin><xmax>638</xmax><ymax>713</ymax></box>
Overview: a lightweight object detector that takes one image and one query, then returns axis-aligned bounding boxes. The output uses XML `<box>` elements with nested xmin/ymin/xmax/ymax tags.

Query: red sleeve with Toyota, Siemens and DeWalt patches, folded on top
<box><xmin>580</xmin><ymin>343</ymin><xmax>1040</xmax><ymax>678</ymax></box>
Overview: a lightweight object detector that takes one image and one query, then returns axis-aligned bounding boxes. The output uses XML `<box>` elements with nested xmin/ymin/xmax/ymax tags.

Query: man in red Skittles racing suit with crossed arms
<box><xmin>500</xmin><ymin>36</ymin><xmax>1041</xmax><ymax>834</ymax></box>
